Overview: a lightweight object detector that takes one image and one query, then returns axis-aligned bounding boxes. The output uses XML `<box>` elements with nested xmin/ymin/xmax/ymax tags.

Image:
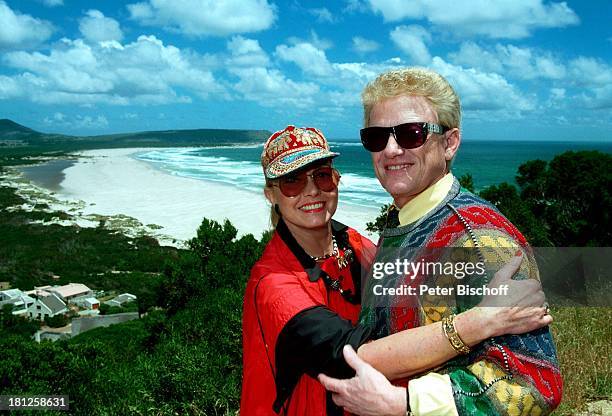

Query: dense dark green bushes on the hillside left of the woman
<box><xmin>0</xmin><ymin>214</ymin><xmax>263</xmax><ymax>415</ymax></box>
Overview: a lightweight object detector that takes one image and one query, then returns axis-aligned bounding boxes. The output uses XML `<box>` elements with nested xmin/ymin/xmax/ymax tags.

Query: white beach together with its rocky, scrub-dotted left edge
<box><xmin>8</xmin><ymin>148</ymin><xmax>379</xmax><ymax>246</ymax></box>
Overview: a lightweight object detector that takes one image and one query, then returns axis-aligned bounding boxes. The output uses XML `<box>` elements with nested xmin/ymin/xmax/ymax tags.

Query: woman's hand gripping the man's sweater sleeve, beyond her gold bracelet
<box><xmin>466</xmin><ymin>255</ymin><xmax>553</xmax><ymax>336</ymax></box>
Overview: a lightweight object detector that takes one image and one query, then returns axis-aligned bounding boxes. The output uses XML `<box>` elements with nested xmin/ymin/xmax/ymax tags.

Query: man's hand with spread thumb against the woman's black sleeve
<box><xmin>318</xmin><ymin>345</ymin><xmax>406</xmax><ymax>416</ymax></box>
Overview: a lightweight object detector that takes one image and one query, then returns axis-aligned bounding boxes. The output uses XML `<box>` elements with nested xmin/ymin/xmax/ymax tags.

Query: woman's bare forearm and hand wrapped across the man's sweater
<box><xmin>357</xmin><ymin>256</ymin><xmax>552</xmax><ymax>380</ymax></box>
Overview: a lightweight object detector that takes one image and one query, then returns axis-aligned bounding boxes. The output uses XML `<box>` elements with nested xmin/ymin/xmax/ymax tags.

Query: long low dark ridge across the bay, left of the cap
<box><xmin>0</xmin><ymin>119</ymin><xmax>271</xmax><ymax>150</ymax></box>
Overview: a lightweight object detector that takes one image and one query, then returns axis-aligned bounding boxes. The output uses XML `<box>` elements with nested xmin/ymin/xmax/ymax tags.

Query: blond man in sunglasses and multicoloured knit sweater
<box><xmin>320</xmin><ymin>68</ymin><xmax>562</xmax><ymax>415</ymax></box>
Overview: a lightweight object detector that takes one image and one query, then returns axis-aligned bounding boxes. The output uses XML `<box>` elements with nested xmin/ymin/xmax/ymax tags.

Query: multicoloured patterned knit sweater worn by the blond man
<box><xmin>360</xmin><ymin>179</ymin><xmax>563</xmax><ymax>415</ymax></box>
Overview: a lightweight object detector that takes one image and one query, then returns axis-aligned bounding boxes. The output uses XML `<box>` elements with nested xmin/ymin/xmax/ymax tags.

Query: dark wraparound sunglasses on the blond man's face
<box><xmin>360</xmin><ymin>123</ymin><xmax>448</xmax><ymax>152</ymax></box>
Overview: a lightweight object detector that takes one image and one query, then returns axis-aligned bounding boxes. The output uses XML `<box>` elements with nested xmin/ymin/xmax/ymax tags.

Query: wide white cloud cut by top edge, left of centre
<box><xmin>127</xmin><ymin>0</ymin><xmax>276</xmax><ymax>36</ymax></box>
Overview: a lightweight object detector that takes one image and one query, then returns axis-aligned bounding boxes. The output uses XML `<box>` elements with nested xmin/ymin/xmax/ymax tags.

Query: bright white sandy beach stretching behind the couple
<box><xmin>56</xmin><ymin>149</ymin><xmax>378</xmax><ymax>244</ymax></box>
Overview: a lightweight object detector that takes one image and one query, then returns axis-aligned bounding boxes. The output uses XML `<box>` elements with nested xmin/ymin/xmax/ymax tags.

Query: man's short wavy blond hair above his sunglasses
<box><xmin>361</xmin><ymin>67</ymin><xmax>461</xmax><ymax>129</ymax></box>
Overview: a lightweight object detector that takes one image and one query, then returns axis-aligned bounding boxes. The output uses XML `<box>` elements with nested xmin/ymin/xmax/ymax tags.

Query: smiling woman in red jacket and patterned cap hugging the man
<box><xmin>241</xmin><ymin>126</ymin><xmax>552</xmax><ymax>415</ymax></box>
